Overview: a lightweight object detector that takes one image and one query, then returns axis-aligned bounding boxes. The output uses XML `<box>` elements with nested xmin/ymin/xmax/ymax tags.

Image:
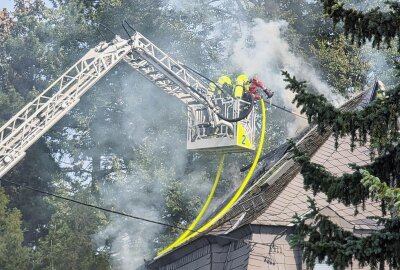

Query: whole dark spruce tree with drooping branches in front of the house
<box><xmin>284</xmin><ymin>0</ymin><xmax>400</xmax><ymax>269</ymax></box>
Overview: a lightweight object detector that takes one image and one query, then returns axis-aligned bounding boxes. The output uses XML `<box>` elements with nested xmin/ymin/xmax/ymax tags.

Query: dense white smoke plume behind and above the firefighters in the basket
<box><xmin>231</xmin><ymin>19</ymin><xmax>344</xmax><ymax>136</ymax></box>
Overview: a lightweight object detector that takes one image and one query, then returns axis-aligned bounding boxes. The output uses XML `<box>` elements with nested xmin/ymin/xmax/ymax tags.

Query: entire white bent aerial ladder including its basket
<box><xmin>0</xmin><ymin>32</ymin><xmax>255</xmax><ymax>177</ymax></box>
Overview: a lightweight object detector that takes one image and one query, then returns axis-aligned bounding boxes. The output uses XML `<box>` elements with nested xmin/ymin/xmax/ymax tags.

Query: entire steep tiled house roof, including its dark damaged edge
<box><xmin>153</xmin><ymin>83</ymin><xmax>381</xmax><ymax>262</ymax></box>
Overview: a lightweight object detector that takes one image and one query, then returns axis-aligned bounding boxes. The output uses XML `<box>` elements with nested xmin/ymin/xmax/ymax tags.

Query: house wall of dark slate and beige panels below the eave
<box><xmin>148</xmin><ymin>225</ymin><xmax>370</xmax><ymax>270</ymax></box>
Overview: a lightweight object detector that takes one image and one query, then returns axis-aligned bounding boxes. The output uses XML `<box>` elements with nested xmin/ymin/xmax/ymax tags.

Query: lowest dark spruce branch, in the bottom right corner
<box><xmin>290</xmin><ymin>198</ymin><xmax>400</xmax><ymax>270</ymax></box>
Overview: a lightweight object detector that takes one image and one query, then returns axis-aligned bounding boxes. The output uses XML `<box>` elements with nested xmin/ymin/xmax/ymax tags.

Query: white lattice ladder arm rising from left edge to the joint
<box><xmin>0</xmin><ymin>37</ymin><xmax>131</xmax><ymax>177</ymax></box>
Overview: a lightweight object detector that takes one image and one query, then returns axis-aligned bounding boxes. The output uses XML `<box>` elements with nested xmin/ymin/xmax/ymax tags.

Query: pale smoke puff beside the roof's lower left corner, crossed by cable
<box><xmin>94</xmin><ymin>163</ymin><xmax>171</xmax><ymax>270</ymax></box>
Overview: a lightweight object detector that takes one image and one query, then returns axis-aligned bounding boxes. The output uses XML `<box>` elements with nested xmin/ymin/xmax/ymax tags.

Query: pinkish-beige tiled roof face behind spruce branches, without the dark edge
<box><xmin>251</xmin><ymin>133</ymin><xmax>381</xmax><ymax>229</ymax></box>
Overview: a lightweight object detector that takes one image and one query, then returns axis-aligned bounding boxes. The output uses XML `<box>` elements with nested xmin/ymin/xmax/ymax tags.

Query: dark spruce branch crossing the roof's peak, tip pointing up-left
<box><xmin>283</xmin><ymin>69</ymin><xmax>400</xmax><ymax>150</ymax></box>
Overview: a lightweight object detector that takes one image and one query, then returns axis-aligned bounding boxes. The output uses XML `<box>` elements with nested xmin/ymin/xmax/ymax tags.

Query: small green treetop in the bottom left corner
<box><xmin>0</xmin><ymin>188</ymin><xmax>30</xmax><ymax>270</ymax></box>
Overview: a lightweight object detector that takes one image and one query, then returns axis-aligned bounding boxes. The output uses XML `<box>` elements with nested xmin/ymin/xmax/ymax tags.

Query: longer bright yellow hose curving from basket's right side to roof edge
<box><xmin>157</xmin><ymin>99</ymin><xmax>266</xmax><ymax>256</ymax></box>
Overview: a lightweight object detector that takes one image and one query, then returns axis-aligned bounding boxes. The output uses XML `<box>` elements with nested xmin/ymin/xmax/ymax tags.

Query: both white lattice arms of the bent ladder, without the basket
<box><xmin>0</xmin><ymin>32</ymin><xmax>253</xmax><ymax>178</ymax></box>
